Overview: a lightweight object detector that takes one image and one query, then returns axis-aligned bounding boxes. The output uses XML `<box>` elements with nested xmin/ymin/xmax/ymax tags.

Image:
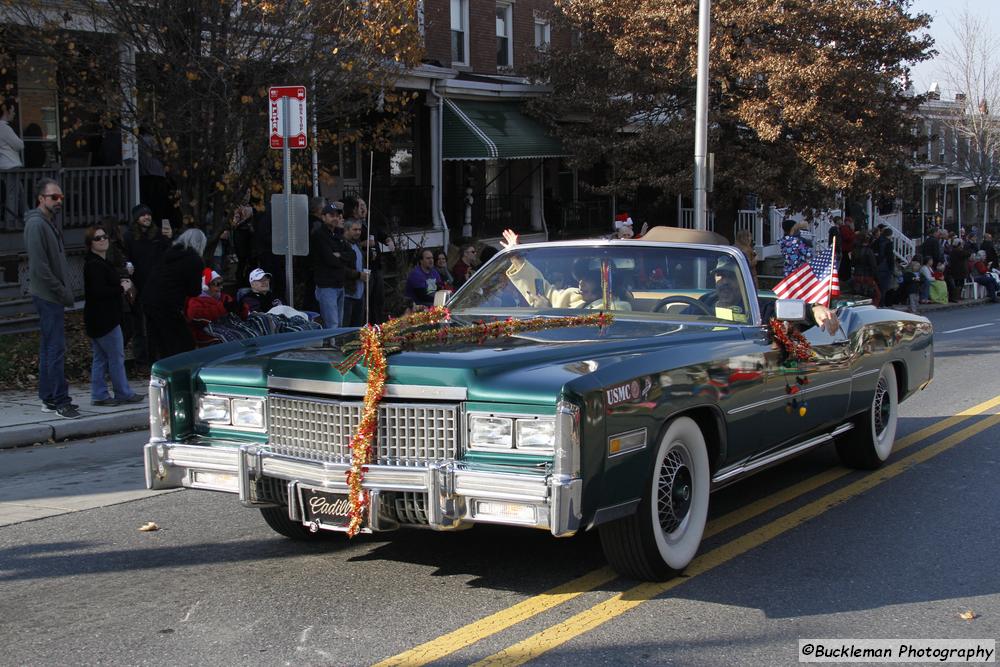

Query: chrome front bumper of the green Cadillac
<box><xmin>144</xmin><ymin>441</ymin><xmax>583</xmax><ymax>537</ymax></box>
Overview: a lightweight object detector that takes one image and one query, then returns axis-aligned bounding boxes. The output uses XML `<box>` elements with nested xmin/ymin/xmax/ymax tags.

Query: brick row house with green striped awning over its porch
<box><xmin>320</xmin><ymin>0</ymin><xmax>612</xmax><ymax>247</ymax></box>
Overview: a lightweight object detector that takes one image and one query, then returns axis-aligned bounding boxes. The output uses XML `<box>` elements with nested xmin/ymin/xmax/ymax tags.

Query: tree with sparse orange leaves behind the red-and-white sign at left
<box><xmin>0</xmin><ymin>0</ymin><xmax>422</xmax><ymax>237</ymax></box>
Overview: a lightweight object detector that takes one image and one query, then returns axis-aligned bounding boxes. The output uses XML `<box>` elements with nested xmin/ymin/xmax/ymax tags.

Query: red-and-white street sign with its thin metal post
<box><xmin>267</xmin><ymin>86</ymin><xmax>307</xmax><ymax>307</ymax></box>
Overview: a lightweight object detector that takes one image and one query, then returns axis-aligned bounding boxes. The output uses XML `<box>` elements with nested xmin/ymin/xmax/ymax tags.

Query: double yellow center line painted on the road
<box><xmin>376</xmin><ymin>396</ymin><xmax>1000</xmax><ymax>667</ymax></box>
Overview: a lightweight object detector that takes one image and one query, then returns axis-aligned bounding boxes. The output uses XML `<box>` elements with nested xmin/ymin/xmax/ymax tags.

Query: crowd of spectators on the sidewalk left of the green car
<box><xmin>24</xmin><ymin>178</ymin><xmax>492</xmax><ymax>419</ymax></box>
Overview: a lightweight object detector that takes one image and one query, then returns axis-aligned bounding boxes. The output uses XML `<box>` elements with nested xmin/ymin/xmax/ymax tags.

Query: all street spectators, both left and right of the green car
<box><xmin>24</xmin><ymin>172</ymin><xmax>1000</xmax><ymax>418</ymax></box>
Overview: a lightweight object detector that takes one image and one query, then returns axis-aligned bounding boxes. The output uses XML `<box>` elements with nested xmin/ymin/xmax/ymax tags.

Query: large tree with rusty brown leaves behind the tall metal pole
<box><xmin>534</xmin><ymin>0</ymin><xmax>931</xmax><ymax>217</ymax></box>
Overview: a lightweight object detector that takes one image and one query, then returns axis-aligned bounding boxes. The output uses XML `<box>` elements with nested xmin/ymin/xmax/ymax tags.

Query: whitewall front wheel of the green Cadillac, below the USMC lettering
<box><xmin>599</xmin><ymin>417</ymin><xmax>712</xmax><ymax>581</ymax></box>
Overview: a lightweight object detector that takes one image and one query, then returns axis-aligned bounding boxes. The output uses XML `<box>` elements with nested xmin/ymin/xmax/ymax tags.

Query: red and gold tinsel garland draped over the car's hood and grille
<box><xmin>336</xmin><ymin>307</ymin><xmax>613</xmax><ymax>537</ymax></box>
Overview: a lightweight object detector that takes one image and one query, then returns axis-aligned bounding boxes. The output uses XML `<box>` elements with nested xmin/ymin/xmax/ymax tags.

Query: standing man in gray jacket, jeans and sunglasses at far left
<box><xmin>24</xmin><ymin>178</ymin><xmax>80</xmax><ymax>419</ymax></box>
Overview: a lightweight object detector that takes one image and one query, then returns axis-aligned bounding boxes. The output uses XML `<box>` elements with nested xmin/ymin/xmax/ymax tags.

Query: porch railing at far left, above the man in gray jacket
<box><xmin>0</xmin><ymin>164</ymin><xmax>134</xmax><ymax>230</ymax></box>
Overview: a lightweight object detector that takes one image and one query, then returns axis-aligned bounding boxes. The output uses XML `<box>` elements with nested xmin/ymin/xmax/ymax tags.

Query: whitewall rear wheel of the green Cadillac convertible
<box><xmin>837</xmin><ymin>364</ymin><xmax>899</xmax><ymax>470</ymax></box>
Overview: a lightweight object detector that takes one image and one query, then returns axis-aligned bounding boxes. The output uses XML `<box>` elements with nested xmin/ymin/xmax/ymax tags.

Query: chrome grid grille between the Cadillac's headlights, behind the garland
<box><xmin>267</xmin><ymin>394</ymin><xmax>459</xmax><ymax>466</ymax></box>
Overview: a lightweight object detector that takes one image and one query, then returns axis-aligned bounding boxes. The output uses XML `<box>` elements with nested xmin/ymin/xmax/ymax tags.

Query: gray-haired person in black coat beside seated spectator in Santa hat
<box><xmin>140</xmin><ymin>229</ymin><xmax>207</xmax><ymax>361</ymax></box>
